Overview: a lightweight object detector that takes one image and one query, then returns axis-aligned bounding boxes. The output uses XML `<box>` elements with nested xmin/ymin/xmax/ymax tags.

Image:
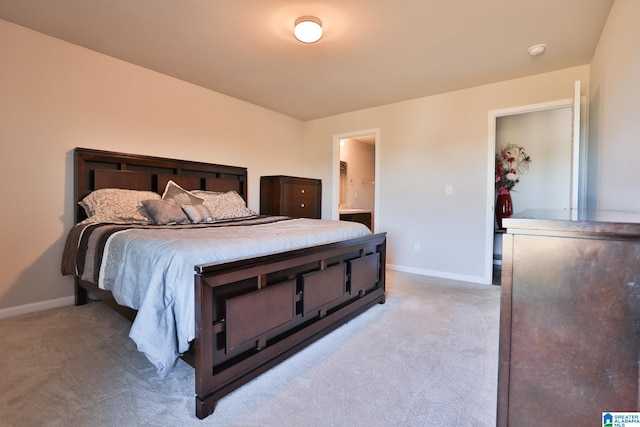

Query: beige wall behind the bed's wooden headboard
<box><xmin>0</xmin><ymin>20</ymin><xmax>303</xmax><ymax>315</ymax></box>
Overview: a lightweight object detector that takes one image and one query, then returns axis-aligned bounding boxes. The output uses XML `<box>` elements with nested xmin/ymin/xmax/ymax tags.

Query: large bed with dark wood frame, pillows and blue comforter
<box><xmin>62</xmin><ymin>148</ymin><xmax>386</xmax><ymax>418</ymax></box>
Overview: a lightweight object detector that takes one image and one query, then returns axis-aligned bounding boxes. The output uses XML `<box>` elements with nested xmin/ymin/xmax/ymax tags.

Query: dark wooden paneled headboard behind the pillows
<box><xmin>74</xmin><ymin>148</ymin><xmax>247</xmax><ymax>222</ymax></box>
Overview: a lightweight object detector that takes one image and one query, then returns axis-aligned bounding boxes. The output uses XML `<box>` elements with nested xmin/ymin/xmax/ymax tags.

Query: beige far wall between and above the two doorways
<box><xmin>304</xmin><ymin>65</ymin><xmax>589</xmax><ymax>283</ymax></box>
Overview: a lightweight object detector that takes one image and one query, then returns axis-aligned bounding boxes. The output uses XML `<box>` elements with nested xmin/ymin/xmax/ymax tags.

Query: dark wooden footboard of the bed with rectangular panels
<box><xmin>194</xmin><ymin>233</ymin><xmax>386</xmax><ymax>418</ymax></box>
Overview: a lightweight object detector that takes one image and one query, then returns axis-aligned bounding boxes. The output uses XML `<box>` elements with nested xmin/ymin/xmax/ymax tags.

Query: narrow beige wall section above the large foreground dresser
<box><xmin>587</xmin><ymin>0</ymin><xmax>640</xmax><ymax>211</ymax></box>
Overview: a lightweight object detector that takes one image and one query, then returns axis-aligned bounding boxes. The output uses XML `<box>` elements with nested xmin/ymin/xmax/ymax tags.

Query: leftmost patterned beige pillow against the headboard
<box><xmin>78</xmin><ymin>188</ymin><xmax>160</xmax><ymax>224</ymax></box>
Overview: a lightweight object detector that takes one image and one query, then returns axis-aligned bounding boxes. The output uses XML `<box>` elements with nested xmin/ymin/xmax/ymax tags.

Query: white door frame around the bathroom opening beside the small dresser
<box><xmin>331</xmin><ymin>128</ymin><xmax>381</xmax><ymax>230</ymax></box>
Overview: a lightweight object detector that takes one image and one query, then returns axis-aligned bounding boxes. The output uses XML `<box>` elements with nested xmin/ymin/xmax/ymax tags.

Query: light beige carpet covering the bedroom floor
<box><xmin>0</xmin><ymin>271</ymin><xmax>500</xmax><ymax>427</ymax></box>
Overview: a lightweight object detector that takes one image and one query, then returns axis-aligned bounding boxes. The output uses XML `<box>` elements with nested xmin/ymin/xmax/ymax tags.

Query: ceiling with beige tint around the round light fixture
<box><xmin>0</xmin><ymin>0</ymin><xmax>613</xmax><ymax>120</ymax></box>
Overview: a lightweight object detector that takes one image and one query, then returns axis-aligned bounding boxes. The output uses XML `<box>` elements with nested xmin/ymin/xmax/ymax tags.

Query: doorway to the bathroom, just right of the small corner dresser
<box><xmin>332</xmin><ymin>129</ymin><xmax>380</xmax><ymax>231</ymax></box>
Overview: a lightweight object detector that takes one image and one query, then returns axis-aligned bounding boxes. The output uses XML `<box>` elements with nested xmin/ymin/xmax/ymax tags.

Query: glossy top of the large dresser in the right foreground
<box><xmin>503</xmin><ymin>209</ymin><xmax>640</xmax><ymax>236</ymax></box>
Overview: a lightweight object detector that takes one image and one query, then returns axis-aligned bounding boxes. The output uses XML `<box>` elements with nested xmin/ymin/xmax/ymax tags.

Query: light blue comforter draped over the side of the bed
<box><xmin>98</xmin><ymin>219</ymin><xmax>371</xmax><ymax>378</ymax></box>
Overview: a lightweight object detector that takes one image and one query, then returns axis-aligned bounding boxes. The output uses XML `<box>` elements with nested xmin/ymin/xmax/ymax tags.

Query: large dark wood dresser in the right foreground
<box><xmin>497</xmin><ymin>210</ymin><xmax>640</xmax><ymax>426</ymax></box>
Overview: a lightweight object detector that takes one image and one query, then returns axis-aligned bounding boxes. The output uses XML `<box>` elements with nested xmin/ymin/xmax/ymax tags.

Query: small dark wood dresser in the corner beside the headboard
<box><xmin>260</xmin><ymin>175</ymin><xmax>322</xmax><ymax>218</ymax></box>
